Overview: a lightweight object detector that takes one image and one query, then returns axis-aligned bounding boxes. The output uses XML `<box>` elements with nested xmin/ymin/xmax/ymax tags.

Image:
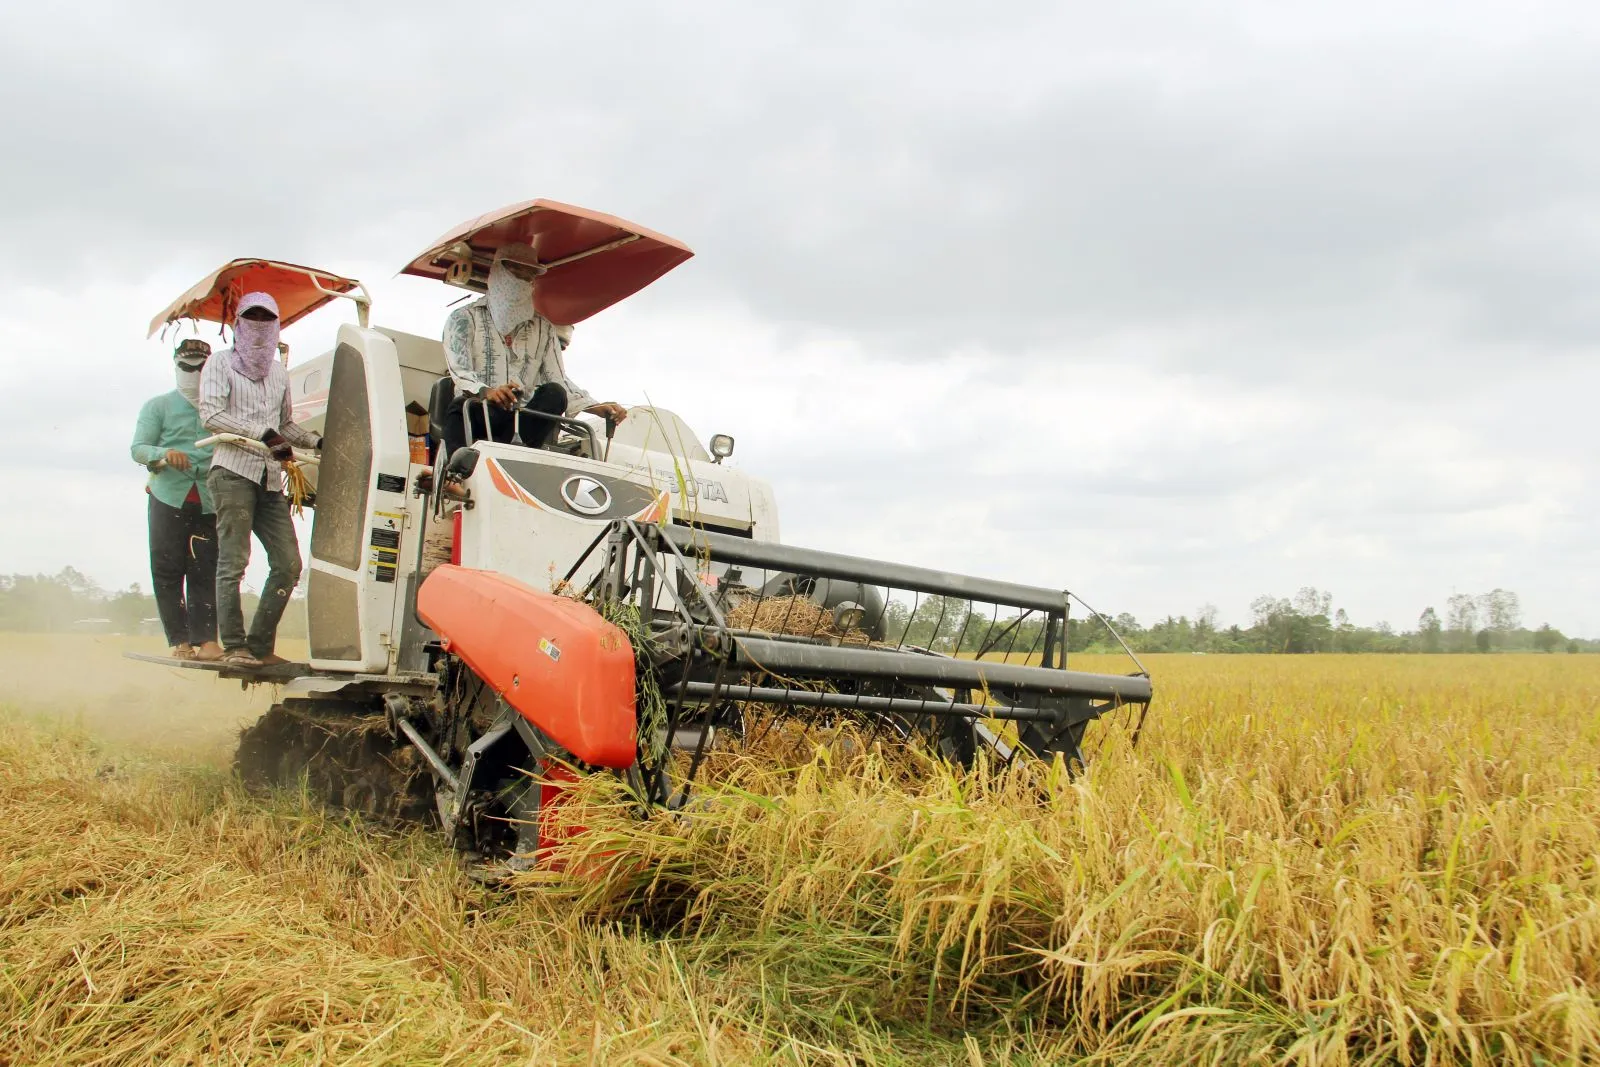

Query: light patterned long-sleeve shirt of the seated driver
<box><xmin>441</xmin><ymin>298</ymin><xmax>598</xmax><ymax>414</ymax></box>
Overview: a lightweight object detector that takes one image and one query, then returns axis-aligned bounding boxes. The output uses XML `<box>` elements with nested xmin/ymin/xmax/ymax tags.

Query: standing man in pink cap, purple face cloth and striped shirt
<box><xmin>200</xmin><ymin>293</ymin><xmax>322</xmax><ymax>667</ymax></box>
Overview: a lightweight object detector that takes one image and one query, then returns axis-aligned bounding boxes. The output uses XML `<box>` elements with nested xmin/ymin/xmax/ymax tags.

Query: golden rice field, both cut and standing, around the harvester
<box><xmin>0</xmin><ymin>637</ymin><xmax>1600</xmax><ymax>1064</ymax></box>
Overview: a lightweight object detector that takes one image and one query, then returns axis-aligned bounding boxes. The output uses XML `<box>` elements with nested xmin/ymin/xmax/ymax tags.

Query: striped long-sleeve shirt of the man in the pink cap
<box><xmin>200</xmin><ymin>349</ymin><xmax>317</xmax><ymax>493</ymax></box>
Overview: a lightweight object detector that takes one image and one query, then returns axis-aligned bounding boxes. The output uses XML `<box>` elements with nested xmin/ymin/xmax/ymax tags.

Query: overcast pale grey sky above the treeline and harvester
<box><xmin>0</xmin><ymin>0</ymin><xmax>1600</xmax><ymax>633</ymax></box>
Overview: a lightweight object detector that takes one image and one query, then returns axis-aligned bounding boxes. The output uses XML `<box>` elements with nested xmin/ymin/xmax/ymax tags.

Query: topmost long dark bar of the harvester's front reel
<box><xmin>659</xmin><ymin>526</ymin><xmax>1067</xmax><ymax>614</ymax></box>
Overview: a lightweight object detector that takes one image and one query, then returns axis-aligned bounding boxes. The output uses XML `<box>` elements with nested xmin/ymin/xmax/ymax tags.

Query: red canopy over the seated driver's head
<box><xmin>400</xmin><ymin>200</ymin><xmax>694</xmax><ymax>326</ymax></box>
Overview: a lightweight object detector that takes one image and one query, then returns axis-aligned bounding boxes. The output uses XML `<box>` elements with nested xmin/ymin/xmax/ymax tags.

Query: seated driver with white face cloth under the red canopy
<box><xmin>445</xmin><ymin>245</ymin><xmax>627</xmax><ymax>453</ymax></box>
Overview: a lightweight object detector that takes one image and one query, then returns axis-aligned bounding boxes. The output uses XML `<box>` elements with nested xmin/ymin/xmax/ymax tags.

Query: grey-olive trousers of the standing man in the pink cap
<box><xmin>205</xmin><ymin>466</ymin><xmax>301</xmax><ymax>657</ymax></box>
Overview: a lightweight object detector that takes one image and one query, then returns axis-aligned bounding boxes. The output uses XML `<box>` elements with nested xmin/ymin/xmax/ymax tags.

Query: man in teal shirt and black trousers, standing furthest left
<box><xmin>130</xmin><ymin>338</ymin><xmax>222</xmax><ymax>661</ymax></box>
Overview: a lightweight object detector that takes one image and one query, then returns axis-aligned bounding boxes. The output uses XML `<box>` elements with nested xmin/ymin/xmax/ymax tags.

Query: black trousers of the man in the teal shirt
<box><xmin>150</xmin><ymin>493</ymin><xmax>216</xmax><ymax>648</ymax></box>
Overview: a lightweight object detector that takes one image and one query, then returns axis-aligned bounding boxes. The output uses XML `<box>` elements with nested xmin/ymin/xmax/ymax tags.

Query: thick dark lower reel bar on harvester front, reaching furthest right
<box><xmin>733</xmin><ymin>637</ymin><xmax>1150</xmax><ymax>704</ymax></box>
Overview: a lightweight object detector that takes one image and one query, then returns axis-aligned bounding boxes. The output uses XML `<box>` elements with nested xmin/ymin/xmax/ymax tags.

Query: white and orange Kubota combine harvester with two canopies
<box><xmin>131</xmin><ymin>200</ymin><xmax>1150</xmax><ymax>865</ymax></box>
